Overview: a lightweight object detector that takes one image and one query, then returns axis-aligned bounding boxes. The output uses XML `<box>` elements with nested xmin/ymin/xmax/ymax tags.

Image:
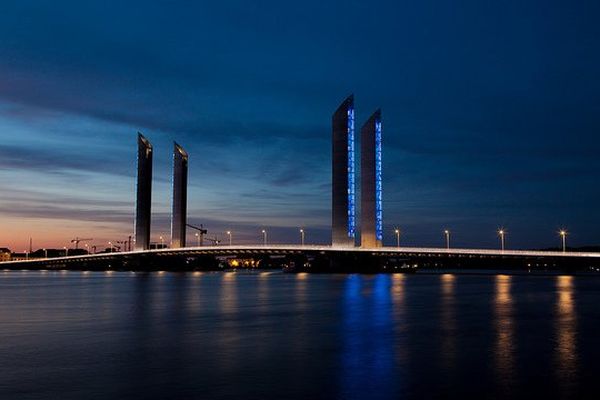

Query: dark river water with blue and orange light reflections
<box><xmin>0</xmin><ymin>271</ymin><xmax>600</xmax><ymax>399</ymax></box>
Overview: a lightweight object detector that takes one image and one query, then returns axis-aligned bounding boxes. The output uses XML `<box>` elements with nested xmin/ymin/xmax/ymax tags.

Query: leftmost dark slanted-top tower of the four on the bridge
<box><xmin>135</xmin><ymin>132</ymin><xmax>152</xmax><ymax>250</ymax></box>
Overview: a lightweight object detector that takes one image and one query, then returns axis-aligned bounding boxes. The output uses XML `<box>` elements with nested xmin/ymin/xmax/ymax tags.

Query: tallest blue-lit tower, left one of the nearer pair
<box><xmin>331</xmin><ymin>95</ymin><xmax>356</xmax><ymax>247</ymax></box>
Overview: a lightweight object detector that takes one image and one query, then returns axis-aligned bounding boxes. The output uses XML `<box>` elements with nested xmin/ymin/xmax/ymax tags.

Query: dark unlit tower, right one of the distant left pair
<box><xmin>171</xmin><ymin>142</ymin><xmax>188</xmax><ymax>248</ymax></box>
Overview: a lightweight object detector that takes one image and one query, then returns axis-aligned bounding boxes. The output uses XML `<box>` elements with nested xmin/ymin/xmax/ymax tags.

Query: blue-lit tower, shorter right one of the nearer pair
<box><xmin>360</xmin><ymin>110</ymin><xmax>383</xmax><ymax>247</ymax></box>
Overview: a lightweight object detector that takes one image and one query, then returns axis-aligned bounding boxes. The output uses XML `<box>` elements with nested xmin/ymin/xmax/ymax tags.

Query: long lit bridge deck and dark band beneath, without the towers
<box><xmin>0</xmin><ymin>245</ymin><xmax>600</xmax><ymax>272</ymax></box>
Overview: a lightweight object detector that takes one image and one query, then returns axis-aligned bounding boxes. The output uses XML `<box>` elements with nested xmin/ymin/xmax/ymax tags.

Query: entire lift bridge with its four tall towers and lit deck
<box><xmin>0</xmin><ymin>95</ymin><xmax>600</xmax><ymax>272</ymax></box>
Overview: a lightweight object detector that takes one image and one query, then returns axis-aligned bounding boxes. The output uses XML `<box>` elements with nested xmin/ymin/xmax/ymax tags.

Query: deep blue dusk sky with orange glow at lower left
<box><xmin>0</xmin><ymin>0</ymin><xmax>600</xmax><ymax>251</ymax></box>
